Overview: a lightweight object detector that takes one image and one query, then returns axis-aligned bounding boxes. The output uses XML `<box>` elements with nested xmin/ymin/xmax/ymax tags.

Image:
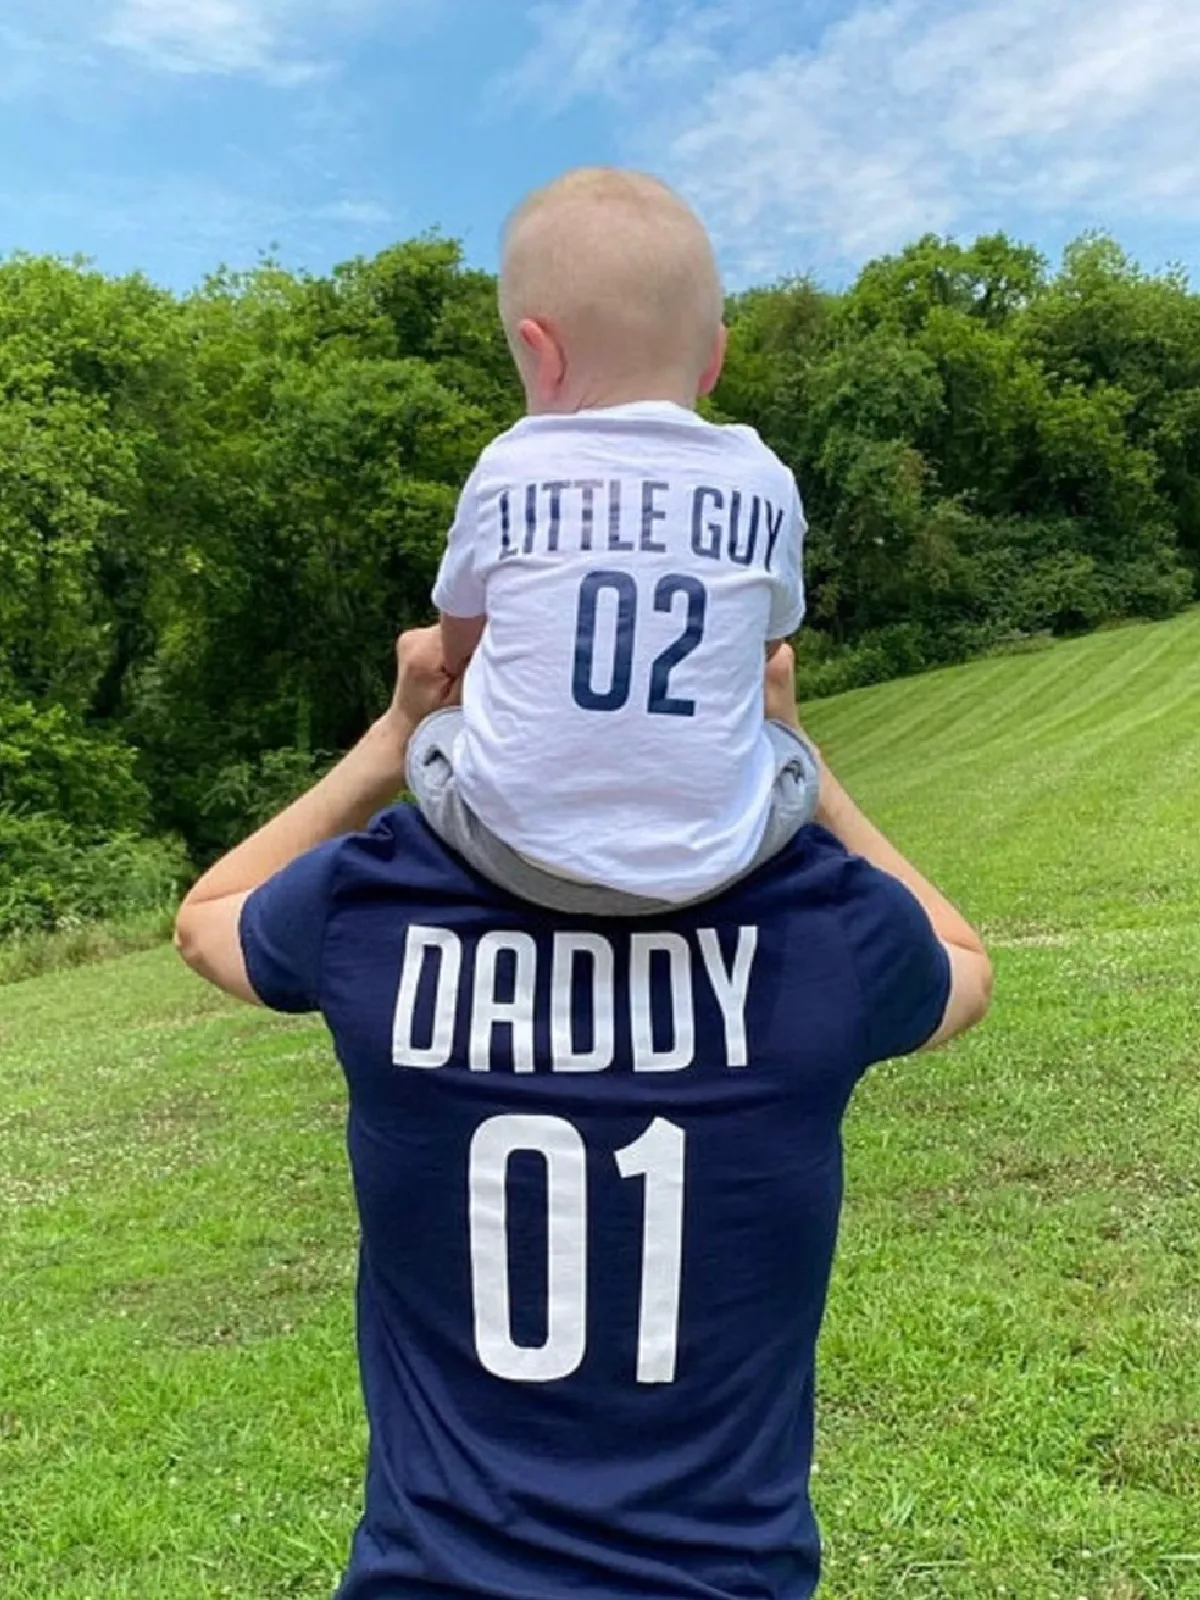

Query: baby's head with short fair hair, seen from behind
<box><xmin>499</xmin><ymin>166</ymin><xmax>725</xmax><ymax>413</ymax></box>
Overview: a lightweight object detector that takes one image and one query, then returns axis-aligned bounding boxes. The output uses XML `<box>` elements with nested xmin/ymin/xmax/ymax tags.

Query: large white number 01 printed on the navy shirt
<box><xmin>470</xmin><ymin>1117</ymin><xmax>686</xmax><ymax>1384</ymax></box>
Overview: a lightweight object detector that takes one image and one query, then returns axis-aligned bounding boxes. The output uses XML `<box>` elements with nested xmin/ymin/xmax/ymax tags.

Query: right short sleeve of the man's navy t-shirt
<box><xmin>842</xmin><ymin>861</ymin><xmax>950</xmax><ymax>1069</ymax></box>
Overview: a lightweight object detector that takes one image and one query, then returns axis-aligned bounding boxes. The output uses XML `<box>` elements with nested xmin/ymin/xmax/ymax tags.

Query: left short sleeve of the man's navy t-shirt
<box><xmin>238</xmin><ymin>840</ymin><xmax>339</xmax><ymax>1011</ymax></box>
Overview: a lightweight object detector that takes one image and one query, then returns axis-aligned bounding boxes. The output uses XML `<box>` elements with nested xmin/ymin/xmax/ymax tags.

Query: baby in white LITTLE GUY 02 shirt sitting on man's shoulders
<box><xmin>408</xmin><ymin>168</ymin><xmax>818</xmax><ymax>915</ymax></box>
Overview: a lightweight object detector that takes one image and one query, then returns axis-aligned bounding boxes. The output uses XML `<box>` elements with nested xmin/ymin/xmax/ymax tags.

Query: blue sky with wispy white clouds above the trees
<box><xmin>0</xmin><ymin>0</ymin><xmax>1200</xmax><ymax>288</ymax></box>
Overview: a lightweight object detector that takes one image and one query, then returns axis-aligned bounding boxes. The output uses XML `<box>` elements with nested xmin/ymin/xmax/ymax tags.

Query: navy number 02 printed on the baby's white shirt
<box><xmin>571</xmin><ymin>573</ymin><xmax>709</xmax><ymax>717</ymax></box>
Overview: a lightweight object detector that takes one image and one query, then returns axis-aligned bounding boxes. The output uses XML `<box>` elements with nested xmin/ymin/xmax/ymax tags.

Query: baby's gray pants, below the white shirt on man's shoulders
<box><xmin>408</xmin><ymin>710</ymin><xmax>821</xmax><ymax>917</ymax></box>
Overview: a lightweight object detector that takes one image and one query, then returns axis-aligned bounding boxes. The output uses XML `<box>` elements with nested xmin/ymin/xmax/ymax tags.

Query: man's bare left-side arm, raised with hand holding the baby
<box><xmin>174</xmin><ymin>627</ymin><xmax>456</xmax><ymax>1003</ymax></box>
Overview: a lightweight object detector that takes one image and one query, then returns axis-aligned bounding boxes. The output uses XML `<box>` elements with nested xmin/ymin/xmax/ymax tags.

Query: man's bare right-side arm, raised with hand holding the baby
<box><xmin>766</xmin><ymin>650</ymin><xmax>992</xmax><ymax>1050</ymax></box>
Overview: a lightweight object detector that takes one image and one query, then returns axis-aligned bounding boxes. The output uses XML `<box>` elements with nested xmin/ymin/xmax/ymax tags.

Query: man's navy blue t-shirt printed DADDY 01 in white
<box><xmin>242</xmin><ymin>806</ymin><xmax>950</xmax><ymax>1600</ymax></box>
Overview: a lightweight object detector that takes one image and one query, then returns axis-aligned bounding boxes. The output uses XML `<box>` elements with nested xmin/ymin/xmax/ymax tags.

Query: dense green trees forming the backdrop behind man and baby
<box><xmin>0</xmin><ymin>224</ymin><xmax>1200</xmax><ymax>934</ymax></box>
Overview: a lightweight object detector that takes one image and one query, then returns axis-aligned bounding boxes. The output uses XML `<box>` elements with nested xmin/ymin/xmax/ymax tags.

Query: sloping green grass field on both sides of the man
<box><xmin>0</xmin><ymin>613</ymin><xmax>1200</xmax><ymax>1600</ymax></box>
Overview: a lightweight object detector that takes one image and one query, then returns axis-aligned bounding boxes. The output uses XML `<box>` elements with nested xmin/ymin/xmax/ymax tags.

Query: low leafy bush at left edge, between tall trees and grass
<box><xmin>0</xmin><ymin>806</ymin><xmax>189</xmax><ymax>939</ymax></box>
